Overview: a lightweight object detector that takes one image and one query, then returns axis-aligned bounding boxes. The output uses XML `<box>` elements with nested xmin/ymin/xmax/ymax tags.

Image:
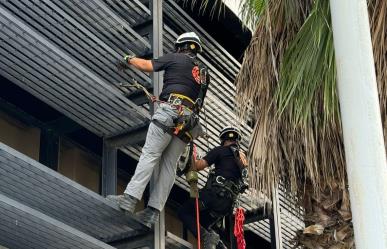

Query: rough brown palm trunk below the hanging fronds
<box><xmin>294</xmin><ymin>185</ymin><xmax>354</xmax><ymax>249</ymax></box>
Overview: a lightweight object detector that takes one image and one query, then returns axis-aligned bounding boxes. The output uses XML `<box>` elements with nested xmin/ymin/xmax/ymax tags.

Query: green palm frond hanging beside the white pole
<box><xmin>276</xmin><ymin>1</ymin><xmax>339</xmax><ymax>124</ymax></box>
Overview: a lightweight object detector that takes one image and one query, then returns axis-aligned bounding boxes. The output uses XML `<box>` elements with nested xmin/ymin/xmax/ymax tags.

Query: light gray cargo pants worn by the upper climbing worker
<box><xmin>125</xmin><ymin>103</ymin><xmax>201</xmax><ymax>211</ymax></box>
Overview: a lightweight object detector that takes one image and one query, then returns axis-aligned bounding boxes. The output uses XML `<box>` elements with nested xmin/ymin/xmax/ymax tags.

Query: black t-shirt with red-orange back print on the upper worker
<box><xmin>152</xmin><ymin>53</ymin><xmax>200</xmax><ymax>101</ymax></box>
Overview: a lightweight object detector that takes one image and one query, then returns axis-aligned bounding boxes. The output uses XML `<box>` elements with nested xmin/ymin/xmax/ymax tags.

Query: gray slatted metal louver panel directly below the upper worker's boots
<box><xmin>0</xmin><ymin>143</ymin><xmax>150</xmax><ymax>241</ymax></box>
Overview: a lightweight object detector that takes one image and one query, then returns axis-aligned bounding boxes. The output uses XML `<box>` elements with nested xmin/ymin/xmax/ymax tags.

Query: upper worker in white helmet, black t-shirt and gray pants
<box><xmin>108</xmin><ymin>32</ymin><xmax>209</xmax><ymax>227</ymax></box>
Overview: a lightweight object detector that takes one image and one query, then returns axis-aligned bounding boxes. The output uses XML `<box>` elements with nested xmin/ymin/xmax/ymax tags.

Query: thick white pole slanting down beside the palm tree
<box><xmin>330</xmin><ymin>0</ymin><xmax>387</xmax><ymax>249</ymax></box>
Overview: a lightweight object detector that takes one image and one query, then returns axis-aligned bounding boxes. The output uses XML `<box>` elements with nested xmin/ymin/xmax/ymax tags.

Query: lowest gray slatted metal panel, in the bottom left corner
<box><xmin>0</xmin><ymin>194</ymin><xmax>113</xmax><ymax>248</ymax></box>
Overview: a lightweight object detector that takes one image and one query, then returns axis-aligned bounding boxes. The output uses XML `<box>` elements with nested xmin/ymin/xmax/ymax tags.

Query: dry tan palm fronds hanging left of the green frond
<box><xmin>236</xmin><ymin>0</ymin><xmax>312</xmax><ymax>196</ymax></box>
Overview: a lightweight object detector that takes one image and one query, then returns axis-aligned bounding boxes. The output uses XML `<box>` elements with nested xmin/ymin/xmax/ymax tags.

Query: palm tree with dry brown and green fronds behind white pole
<box><xmin>236</xmin><ymin>0</ymin><xmax>387</xmax><ymax>249</ymax></box>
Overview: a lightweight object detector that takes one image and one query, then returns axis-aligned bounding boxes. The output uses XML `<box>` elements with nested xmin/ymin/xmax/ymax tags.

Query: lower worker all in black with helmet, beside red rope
<box><xmin>178</xmin><ymin>127</ymin><xmax>247</xmax><ymax>249</ymax></box>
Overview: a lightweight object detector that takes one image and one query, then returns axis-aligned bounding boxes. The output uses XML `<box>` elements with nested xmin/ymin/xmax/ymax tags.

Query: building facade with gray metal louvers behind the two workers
<box><xmin>0</xmin><ymin>0</ymin><xmax>303</xmax><ymax>248</ymax></box>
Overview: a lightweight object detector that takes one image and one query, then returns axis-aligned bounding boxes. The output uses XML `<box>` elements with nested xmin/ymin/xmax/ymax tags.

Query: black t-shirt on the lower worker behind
<box><xmin>203</xmin><ymin>146</ymin><xmax>241</xmax><ymax>181</ymax></box>
